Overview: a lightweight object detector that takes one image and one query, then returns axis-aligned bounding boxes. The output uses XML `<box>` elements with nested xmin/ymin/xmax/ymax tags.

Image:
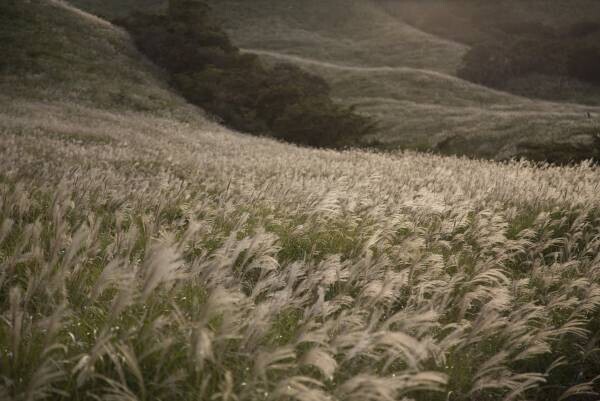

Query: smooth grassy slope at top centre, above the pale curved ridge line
<box><xmin>208</xmin><ymin>0</ymin><xmax>466</xmax><ymax>73</ymax></box>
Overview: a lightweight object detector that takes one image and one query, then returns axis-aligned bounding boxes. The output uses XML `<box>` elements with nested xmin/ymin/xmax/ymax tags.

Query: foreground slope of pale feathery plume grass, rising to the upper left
<box><xmin>0</xmin><ymin>0</ymin><xmax>600</xmax><ymax>401</ymax></box>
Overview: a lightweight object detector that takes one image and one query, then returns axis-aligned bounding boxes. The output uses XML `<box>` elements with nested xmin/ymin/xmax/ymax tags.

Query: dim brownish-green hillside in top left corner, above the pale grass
<box><xmin>0</xmin><ymin>0</ymin><xmax>192</xmax><ymax>119</ymax></box>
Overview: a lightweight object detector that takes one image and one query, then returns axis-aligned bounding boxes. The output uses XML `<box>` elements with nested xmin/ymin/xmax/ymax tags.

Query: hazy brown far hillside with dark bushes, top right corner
<box><xmin>378</xmin><ymin>0</ymin><xmax>600</xmax><ymax>106</ymax></box>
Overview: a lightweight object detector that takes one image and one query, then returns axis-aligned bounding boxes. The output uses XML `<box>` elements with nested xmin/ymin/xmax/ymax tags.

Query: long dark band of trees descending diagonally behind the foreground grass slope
<box><xmin>117</xmin><ymin>0</ymin><xmax>374</xmax><ymax>147</ymax></box>
